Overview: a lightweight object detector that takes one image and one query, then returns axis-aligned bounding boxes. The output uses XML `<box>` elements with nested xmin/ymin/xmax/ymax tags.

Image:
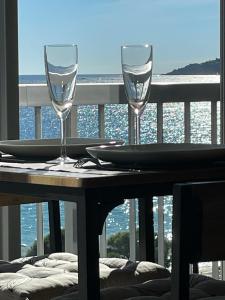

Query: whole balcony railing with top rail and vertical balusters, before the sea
<box><xmin>19</xmin><ymin>77</ymin><xmax>220</xmax><ymax>277</ymax></box>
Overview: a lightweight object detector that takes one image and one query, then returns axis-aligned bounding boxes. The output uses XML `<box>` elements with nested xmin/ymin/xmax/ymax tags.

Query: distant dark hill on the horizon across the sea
<box><xmin>166</xmin><ymin>58</ymin><xmax>220</xmax><ymax>75</ymax></box>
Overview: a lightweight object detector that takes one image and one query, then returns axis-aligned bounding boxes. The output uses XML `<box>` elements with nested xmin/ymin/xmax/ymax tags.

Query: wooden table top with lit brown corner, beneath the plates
<box><xmin>0</xmin><ymin>164</ymin><xmax>225</xmax><ymax>188</ymax></box>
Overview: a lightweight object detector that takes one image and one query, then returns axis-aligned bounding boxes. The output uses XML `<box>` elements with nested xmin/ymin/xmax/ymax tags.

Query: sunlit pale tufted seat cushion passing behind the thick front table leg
<box><xmin>0</xmin><ymin>253</ymin><xmax>170</xmax><ymax>300</ymax></box>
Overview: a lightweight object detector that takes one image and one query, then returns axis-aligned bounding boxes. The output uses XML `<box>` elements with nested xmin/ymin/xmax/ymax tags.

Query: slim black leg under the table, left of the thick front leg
<box><xmin>48</xmin><ymin>201</ymin><xmax>62</xmax><ymax>252</ymax></box>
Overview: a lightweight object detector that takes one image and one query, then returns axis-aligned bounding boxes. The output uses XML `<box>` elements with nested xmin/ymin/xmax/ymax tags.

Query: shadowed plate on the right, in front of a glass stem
<box><xmin>87</xmin><ymin>143</ymin><xmax>225</xmax><ymax>167</ymax></box>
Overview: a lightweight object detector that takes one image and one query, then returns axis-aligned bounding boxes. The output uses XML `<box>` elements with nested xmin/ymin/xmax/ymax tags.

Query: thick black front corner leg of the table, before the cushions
<box><xmin>77</xmin><ymin>190</ymin><xmax>100</xmax><ymax>300</ymax></box>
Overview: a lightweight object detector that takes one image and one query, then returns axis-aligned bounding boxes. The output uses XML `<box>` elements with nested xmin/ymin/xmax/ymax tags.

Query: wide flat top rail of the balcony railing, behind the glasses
<box><xmin>19</xmin><ymin>82</ymin><xmax>220</xmax><ymax>107</ymax></box>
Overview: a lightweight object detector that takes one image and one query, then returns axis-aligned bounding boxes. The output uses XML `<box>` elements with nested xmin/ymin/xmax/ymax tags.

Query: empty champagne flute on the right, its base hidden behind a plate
<box><xmin>121</xmin><ymin>44</ymin><xmax>153</xmax><ymax>144</ymax></box>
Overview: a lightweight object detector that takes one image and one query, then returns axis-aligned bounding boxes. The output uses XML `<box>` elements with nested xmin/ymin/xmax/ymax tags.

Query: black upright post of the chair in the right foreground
<box><xmin>171</xmin><ymin>185</ymin><xmax>191</xmax><ymax>300</ymax></box>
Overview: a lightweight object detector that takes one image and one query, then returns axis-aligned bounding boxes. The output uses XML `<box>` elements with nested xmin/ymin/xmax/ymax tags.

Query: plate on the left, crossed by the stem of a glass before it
<box><xmin>0</xmin><ymin>138</ymin><xmax>123</xmax><ymax>159</ymax></box>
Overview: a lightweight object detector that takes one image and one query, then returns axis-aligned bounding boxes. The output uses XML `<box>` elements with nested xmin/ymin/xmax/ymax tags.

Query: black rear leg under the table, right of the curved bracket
<box><xmin>138</xmin><ymin>196</ymin><xmax>155</xmax><ymax>262</ymax></box>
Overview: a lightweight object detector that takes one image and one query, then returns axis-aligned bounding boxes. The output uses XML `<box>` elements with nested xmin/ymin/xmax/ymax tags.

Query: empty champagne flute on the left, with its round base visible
<box><xmin>44</xmin><ymin>44</ymin><xmax>78</xmax><ymax>165</ymax></box>
